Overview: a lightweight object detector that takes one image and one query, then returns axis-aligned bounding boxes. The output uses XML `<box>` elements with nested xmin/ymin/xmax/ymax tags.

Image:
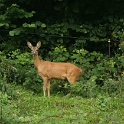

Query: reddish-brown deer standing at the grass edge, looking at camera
<box><xmin>27</xmin><ymin>41</ymin><xmax>82</xmax><ymax>96</ymax></box>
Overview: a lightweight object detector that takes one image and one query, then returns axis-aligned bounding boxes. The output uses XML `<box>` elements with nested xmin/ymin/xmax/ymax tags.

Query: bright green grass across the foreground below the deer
<box><xmin>0</xmin><ymin>88</ymin><xmax>124</xmax><ymax>124</ymax></box>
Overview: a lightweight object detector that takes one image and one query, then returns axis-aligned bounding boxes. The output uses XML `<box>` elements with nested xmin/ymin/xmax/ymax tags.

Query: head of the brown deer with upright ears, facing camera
<box><xmin>27</xmin><ymin>41</ymin><xmax>41</xmax><ymax>56</ymax></box>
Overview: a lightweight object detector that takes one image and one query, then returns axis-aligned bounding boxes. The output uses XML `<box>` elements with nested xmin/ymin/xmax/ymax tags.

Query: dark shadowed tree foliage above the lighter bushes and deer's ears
<box><xmin>0</xmin><ymin>0</ymin><xmax>124</xmax><ymax>55</ymax></box>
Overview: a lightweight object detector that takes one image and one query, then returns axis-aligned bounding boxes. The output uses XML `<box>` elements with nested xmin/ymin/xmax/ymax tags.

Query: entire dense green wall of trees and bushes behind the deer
<box><xmin>0</xmin><ymin>0</ymin><xmax>124</xmax><ymax>94</ymax></box>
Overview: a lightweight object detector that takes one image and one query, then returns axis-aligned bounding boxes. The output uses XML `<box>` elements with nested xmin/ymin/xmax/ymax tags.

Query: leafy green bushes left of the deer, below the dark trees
<box><xmin>0</xmin><ymin>50</ymin><xmax>42</xmax><ymax>92</ymax></box>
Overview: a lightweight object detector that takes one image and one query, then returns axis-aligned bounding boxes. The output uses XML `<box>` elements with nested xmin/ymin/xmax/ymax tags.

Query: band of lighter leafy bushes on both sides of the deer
<box><xmin>0</xmin><ymin>46</ymin><xmax>124</xmax><ymax>97</ymax></box>
